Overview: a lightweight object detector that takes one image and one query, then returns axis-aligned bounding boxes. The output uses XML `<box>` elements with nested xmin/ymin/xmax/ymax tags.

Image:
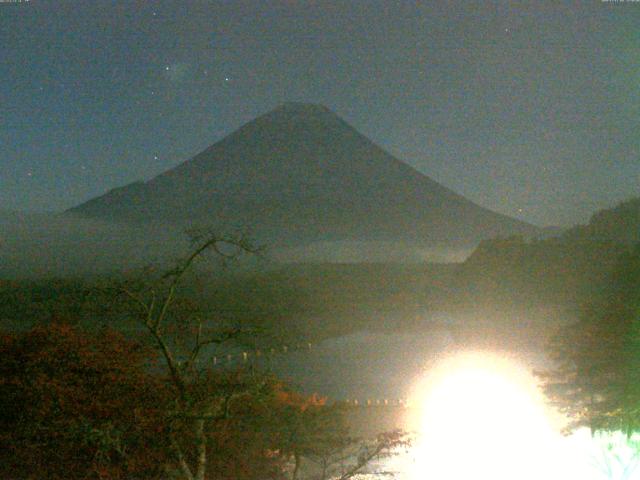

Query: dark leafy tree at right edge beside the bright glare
<box><xmin>541</xmin><ymin>244</ymin><xmax>640</xmax><ymax>434</ymax></box>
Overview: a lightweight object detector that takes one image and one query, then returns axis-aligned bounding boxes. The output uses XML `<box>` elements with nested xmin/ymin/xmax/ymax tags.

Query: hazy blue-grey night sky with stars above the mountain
<box><xmin>0</xmin><ymin>0</ymin><xmax>640</xmax><ymax>224</ymax></box>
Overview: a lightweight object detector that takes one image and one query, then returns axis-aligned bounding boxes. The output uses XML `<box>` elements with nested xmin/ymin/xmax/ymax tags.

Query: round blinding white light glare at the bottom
<box><xmin>410</xmin><ymin>353</ymin><xmax>606</xmax><ymax>480</ymax></box>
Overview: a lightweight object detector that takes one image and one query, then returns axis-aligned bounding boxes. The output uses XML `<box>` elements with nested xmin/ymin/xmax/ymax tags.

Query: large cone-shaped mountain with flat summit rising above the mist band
<box><xmin>69</xmin><ymin>103</ymin><xmax>537</xmax><ymax>247</ymax></box>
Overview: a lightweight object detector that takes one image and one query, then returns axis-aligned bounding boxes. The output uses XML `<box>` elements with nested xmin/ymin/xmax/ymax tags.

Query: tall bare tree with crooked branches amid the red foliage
<box><xmin>116</xmin><ymin>230</ymin><xmax>261</xmax><ymax>480</ymax></box>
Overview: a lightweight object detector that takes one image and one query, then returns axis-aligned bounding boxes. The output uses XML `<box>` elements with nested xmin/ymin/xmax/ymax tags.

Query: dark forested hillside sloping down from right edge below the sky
<box><xmin>453</xmin><ymin>198</ymin><xmax>640</xmax><ymax>307</ymax></box>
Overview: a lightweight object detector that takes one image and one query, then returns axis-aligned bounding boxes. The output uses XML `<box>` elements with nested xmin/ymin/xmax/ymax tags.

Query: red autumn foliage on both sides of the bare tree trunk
<box><xmin>0</xmin><ymin>323</ymin><xmax>362</xmax><ymax>480</ymax></box>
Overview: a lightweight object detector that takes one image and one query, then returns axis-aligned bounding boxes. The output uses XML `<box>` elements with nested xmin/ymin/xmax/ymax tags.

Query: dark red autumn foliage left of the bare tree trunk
<box><xmin>0</xmin><ymin>324</ymin><xmax>170</xmax><ymax>479</ymax></box>
